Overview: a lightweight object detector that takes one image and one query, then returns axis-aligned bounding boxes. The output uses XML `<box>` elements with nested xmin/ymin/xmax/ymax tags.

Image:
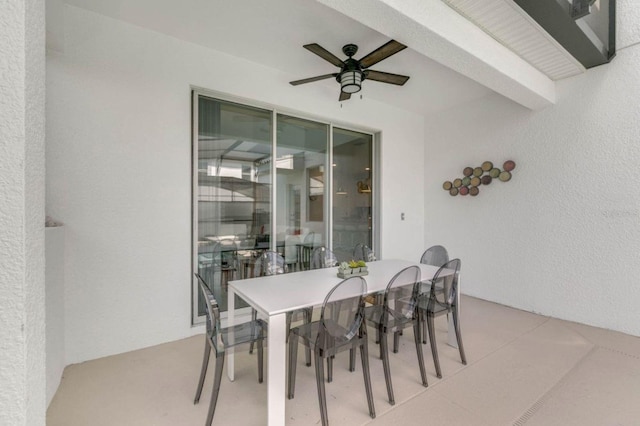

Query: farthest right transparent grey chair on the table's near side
<box><xmin>418</xmin><ymin>259</ymin><xmax>467</xmax><ymax>378</ymax></box>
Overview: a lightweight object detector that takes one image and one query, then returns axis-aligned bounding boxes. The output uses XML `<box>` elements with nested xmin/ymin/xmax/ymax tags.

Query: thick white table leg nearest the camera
<box><xmin>267</xmin><ymin>313</ymin><xmax>287</xmax><ymax>426</ymax></box>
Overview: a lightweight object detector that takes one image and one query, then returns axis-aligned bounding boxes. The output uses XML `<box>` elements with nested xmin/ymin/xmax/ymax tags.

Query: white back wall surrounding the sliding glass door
<box><xmin>47</xmin><ymin>6</ymin><xmax>424</xmax><ymax>363</ymax></box>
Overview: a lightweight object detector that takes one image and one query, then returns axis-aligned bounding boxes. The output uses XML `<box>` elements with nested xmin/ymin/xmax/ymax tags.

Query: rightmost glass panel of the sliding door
<box><xmin>332</xmin><ymin>127</ymin><xmax>374</xmax><ymax>261</ymax></box>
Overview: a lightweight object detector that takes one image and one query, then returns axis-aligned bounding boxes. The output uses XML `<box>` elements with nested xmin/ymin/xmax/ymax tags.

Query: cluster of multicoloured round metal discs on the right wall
<box><xmin>442</xmin><ymin>160</ymin><xmax>516</xmax><ymax>197</ymax></box>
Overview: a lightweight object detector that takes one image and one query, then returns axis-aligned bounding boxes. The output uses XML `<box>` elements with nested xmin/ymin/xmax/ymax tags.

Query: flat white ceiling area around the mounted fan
<box><xmin>46</xmin><ymin>0</ymin><xmax>576</xmax><ymax>115</ymax></box>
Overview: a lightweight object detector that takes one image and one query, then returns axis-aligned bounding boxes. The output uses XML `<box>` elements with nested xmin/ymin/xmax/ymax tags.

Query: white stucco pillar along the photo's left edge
<box><xmin>0</xmin><ymin>0</ymin><xmax>46</xmax><ymax>425</ymax></box>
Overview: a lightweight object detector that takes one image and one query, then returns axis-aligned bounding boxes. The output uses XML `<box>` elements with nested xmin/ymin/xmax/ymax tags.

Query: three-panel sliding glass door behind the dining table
<box><xmin>193</xmin><ymin>91</ymin><xmax>374</xmax><ymax>323</ymax></box>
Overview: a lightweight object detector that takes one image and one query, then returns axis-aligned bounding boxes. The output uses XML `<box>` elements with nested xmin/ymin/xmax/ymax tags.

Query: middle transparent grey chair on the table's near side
<box><xmin>365</xmin><ymin>266</ymin><xmax>428</xmax><ymax>405</ymax></box>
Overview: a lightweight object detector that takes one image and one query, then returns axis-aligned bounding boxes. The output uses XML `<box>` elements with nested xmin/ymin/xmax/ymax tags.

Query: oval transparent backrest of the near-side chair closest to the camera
<box><xmin>316</xmin><ymin>277</ymin><xmax>367</xmax><ymax>352</ymax></box>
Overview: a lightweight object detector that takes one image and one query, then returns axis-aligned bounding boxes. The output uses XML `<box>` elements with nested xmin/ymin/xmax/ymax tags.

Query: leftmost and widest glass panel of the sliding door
<box><xmin>194</xmin><ymin>96</ymin><xmax>272</xmax><ymax>317</ymax></box>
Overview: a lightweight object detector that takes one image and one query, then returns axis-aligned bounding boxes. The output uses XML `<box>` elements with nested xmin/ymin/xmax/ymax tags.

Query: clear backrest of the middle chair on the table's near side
<box><xmin>382</xmin><ymin>266</ymin><xmax>421</xmax><ymax>324</ymax></box>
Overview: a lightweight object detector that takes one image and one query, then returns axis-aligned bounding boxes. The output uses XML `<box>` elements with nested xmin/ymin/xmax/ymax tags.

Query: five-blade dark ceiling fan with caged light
<box><xmin>290</xmin><ymin>40</ymin><xmax>409</xmax><ymax>101</ymax></box>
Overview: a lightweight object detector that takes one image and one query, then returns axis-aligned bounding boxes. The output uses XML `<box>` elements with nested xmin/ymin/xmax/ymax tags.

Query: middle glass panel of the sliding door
<box><xmin>275</xmin><ymin>114</ymin><xmax>329</xmax><ymax>272</ymax></box>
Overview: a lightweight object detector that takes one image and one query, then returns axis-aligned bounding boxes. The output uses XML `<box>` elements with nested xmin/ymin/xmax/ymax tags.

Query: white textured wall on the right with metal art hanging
<box><xmin>425</xmin><ymin>7</ymin><xmax>640</xmax><ymax>335</ymax></box>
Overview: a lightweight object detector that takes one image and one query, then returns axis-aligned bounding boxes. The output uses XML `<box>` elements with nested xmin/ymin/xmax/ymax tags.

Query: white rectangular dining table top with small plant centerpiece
<box><xmin>229</xmin><ymin>259</ymin><xmax>453</xmax><ymax>316</ymax></box>
